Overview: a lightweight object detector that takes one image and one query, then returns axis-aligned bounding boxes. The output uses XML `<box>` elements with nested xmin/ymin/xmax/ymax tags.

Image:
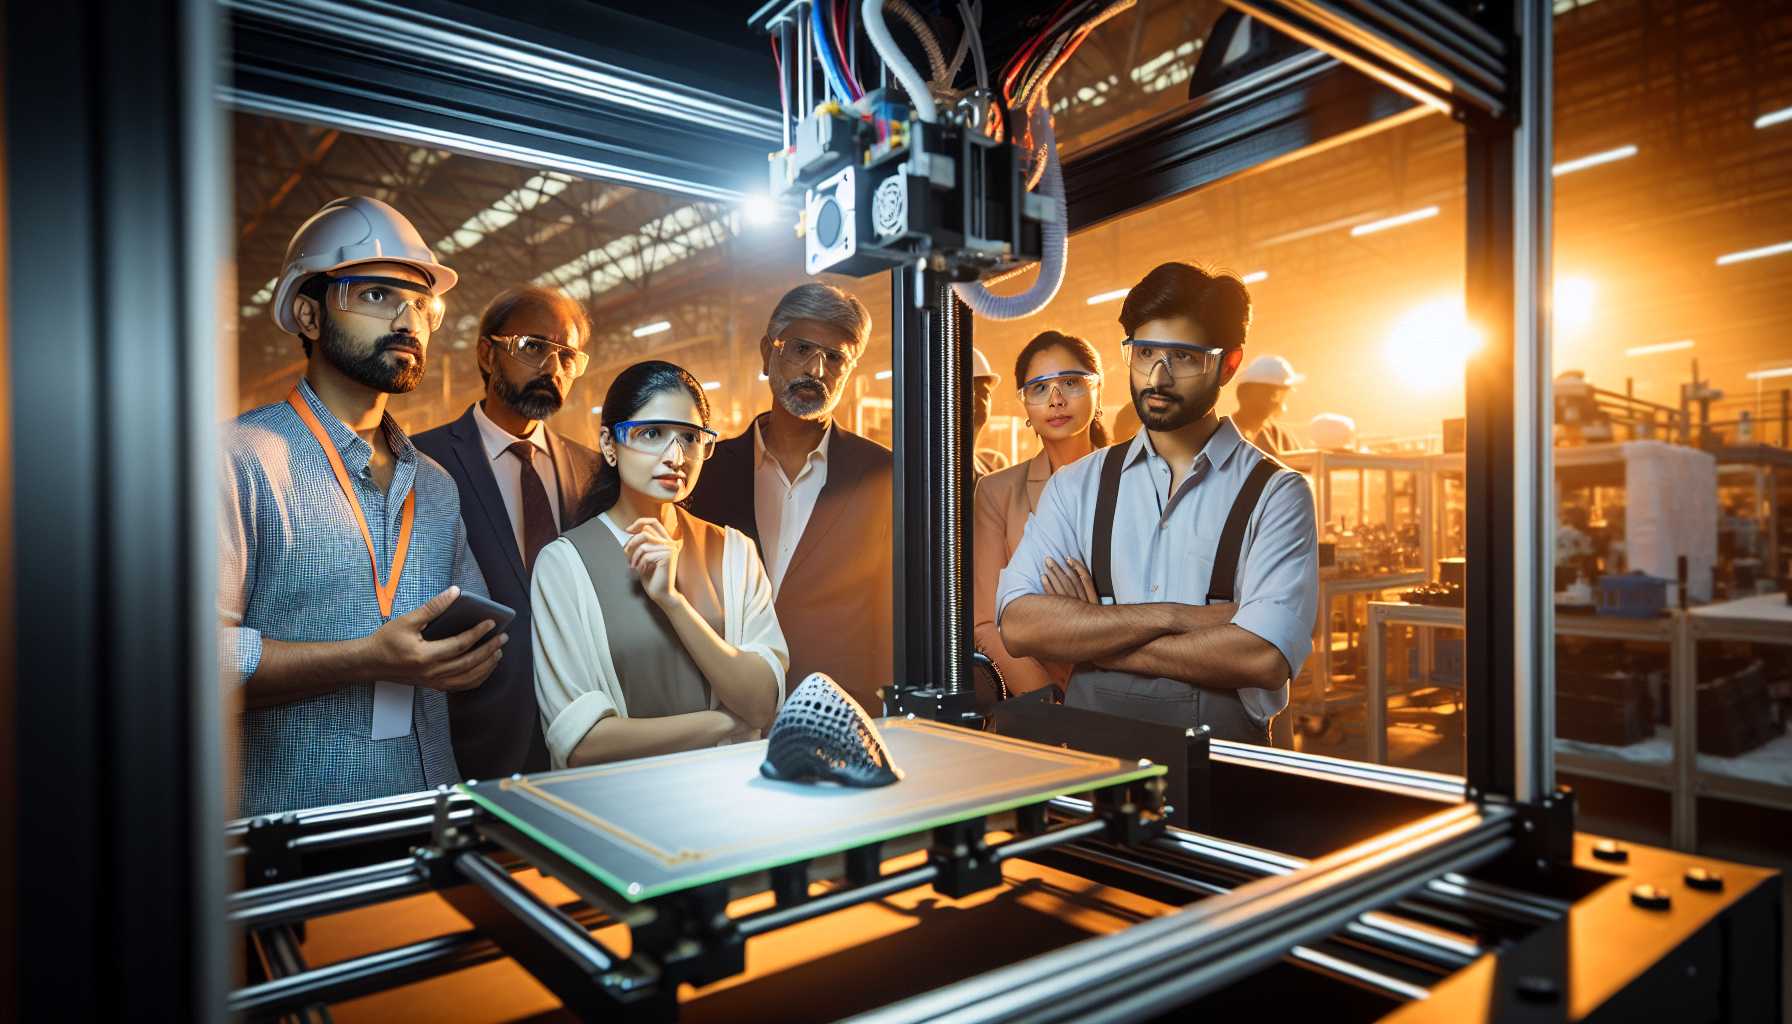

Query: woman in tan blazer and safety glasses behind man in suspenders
<box><xmin>971</xmin><ymin>330</ymin><xmax>1107</xmax><ymax>694</ymax></box>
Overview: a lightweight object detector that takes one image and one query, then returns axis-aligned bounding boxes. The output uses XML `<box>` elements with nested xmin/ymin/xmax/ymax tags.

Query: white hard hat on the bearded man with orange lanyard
<box><xmin>274</xmin><ymin>195</ymin><xmax>461</xmax><ymax>334</ymax></box>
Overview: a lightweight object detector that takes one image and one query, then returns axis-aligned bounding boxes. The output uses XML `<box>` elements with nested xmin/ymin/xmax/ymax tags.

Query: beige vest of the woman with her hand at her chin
<box><xmin>564</xmin><ymin>506</ymin><xmax>724</xmax><ymax>717</ymax></box>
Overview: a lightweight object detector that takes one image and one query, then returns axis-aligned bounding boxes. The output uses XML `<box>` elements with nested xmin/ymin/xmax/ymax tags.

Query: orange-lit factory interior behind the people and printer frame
<box><xmin>226</xmin><ymin>0</ymin><xmax>1792</xmax><ymax>857</ymax></box>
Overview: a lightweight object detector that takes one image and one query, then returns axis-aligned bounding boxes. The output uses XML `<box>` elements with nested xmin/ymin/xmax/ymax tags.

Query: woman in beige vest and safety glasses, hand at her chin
<box><xmin>530</xmin><ymin>360</ymin><xmax>790</xmax><ymax>768</ymax></box>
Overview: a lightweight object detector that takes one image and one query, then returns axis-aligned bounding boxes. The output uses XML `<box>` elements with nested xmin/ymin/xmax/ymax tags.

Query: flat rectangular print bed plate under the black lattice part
<box><xmin>461</xmin><ymin>719</ymin><xmax>1165</xmax><ymax>904</ymax></box>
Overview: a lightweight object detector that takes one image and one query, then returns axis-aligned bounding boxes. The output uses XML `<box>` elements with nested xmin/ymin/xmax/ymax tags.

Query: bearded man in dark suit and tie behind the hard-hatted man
<box><xmin>412</xmin><ymin>287</ymin><xmax>597</xmax><ymax>778</ymax></box>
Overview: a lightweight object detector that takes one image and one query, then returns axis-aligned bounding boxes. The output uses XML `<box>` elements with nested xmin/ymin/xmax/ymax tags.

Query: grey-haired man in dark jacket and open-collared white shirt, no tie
<box><xmin>688</xmin><ymin>283</ymin><xmax>894</xmax><ymax>716</ymax></box>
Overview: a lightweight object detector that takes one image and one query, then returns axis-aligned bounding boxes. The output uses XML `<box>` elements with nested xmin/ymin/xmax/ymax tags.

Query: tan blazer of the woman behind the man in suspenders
<box><xmin>971</xmin><ymin>452</ymin><xmax>1072</xmax><ymax>694</ymax></box>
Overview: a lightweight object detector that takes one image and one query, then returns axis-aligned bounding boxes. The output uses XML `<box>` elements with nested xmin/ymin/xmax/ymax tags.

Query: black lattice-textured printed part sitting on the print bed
<box><xmin>760</xmin><ymin>673</ymin><xmax>901</xmax><ymax>789</ymax></box>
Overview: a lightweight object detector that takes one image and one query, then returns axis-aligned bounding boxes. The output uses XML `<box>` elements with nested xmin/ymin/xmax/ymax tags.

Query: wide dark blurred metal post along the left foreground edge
<box><xmin>0</xmin><ymin>0</ymin><xmax>231</xmax><ymax>1020</ymax></box>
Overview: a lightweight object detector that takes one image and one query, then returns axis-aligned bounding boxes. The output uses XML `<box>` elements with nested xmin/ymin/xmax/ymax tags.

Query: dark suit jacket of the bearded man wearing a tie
<box><xmin>410</xmin><ymin>407</ymin><xmax>597</xmax><ymax>778</ymax></box>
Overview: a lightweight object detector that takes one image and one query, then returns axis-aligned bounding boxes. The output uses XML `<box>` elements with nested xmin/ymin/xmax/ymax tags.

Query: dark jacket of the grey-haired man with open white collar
<box><xmin>688</xmin><ymin>414</ymin><xmax>894</xmax><ymax>716</ymax></box>
